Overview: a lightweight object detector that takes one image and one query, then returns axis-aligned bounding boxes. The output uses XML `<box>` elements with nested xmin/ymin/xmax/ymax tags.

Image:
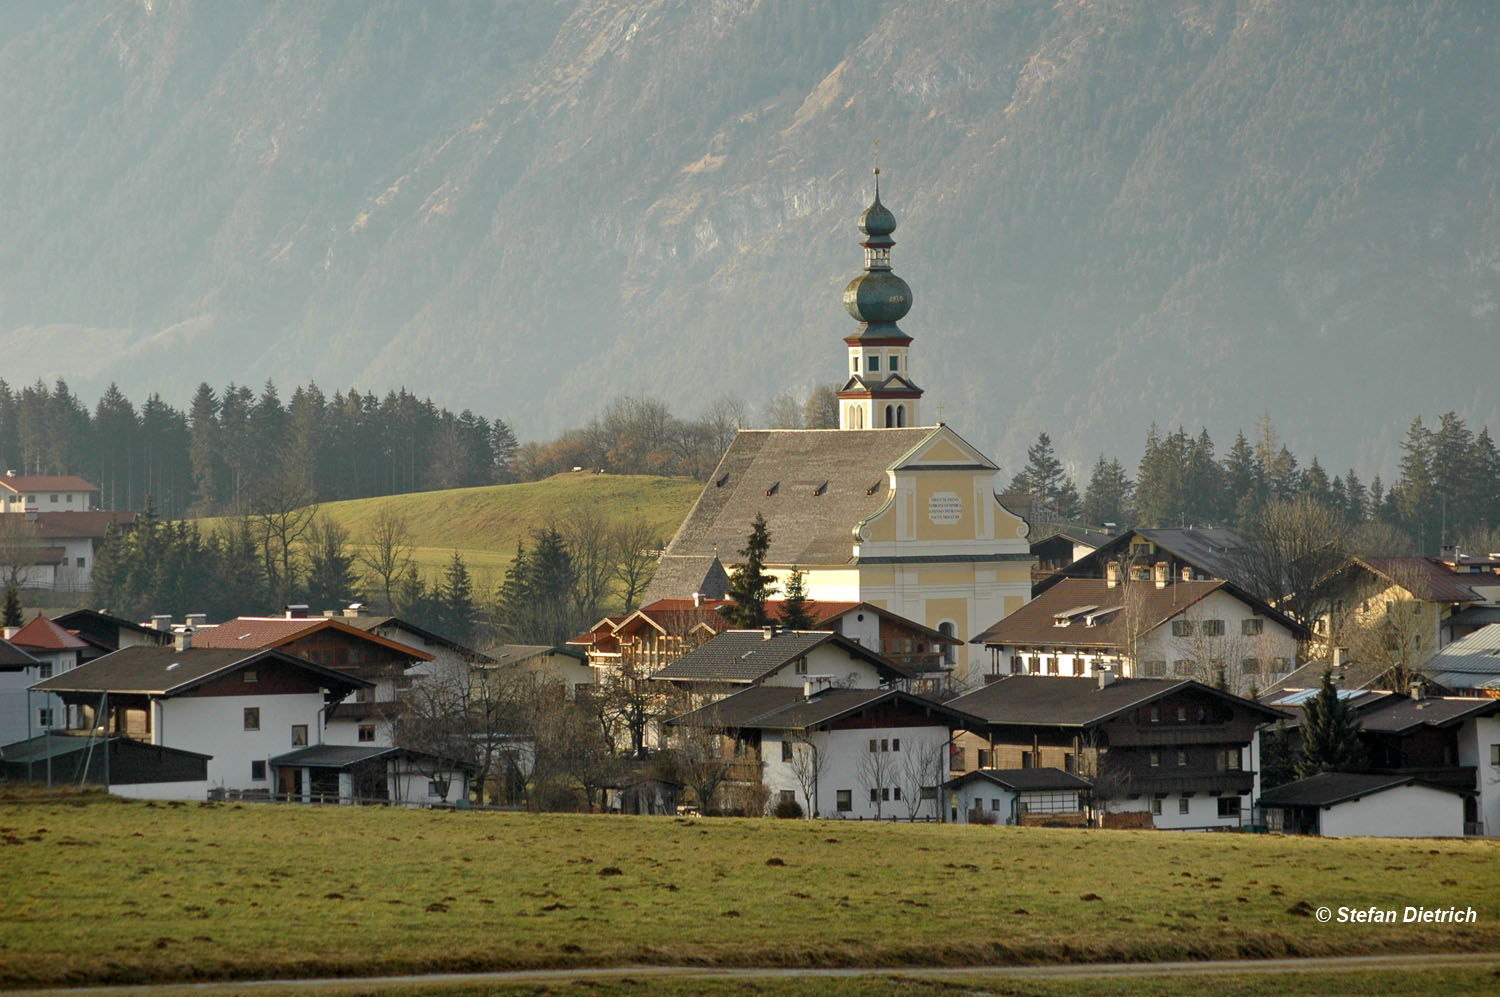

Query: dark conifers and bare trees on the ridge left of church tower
<box><xmin>0</xmin><ymin>379</ymin><xmax>837</xmax><ymax>519</ymax></box>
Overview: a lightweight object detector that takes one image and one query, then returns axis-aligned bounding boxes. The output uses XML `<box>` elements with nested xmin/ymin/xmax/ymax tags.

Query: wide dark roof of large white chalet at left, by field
<box><xmin>32</xmin><ymin>646</ymin><xmax>374</xmax><ymax>696</ymax></box>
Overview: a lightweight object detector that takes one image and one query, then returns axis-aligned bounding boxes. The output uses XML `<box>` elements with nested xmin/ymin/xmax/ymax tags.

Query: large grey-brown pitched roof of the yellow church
<box><xmin>645</xmin><ymin>426</ymin><xmax>941</xmax><ymax>593</ymax></box>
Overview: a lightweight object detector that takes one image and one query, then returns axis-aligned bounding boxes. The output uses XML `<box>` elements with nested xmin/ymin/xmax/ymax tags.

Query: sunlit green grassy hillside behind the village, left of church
<box><xmin>201</xmin><ymin>474</ymin><xmax>704</xmax><ymax>585</ymax></box>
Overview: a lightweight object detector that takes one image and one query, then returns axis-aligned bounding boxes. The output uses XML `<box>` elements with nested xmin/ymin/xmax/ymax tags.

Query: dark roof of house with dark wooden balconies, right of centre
<box><xmin>948</xmin><ymin>675</ymin><xmax>1281</xmax><ymax>727</ymax></box>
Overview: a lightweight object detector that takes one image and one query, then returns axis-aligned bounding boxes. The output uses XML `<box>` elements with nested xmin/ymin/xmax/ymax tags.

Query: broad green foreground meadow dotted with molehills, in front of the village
<box><xmin>0</xmin><ymin>798</ymin><xmax>1500</xmax><ymax>993</ymax></box>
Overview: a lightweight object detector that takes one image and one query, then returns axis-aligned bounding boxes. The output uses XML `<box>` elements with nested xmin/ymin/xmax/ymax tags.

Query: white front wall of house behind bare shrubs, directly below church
<box><xmin>761</xmin><ymin>727</ymin><xmax>951</xmax><ymax>820</ymax></box>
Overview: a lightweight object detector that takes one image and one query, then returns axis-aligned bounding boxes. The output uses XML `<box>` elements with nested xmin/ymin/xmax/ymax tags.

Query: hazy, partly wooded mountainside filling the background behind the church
<box><xmin>0</xmin><ymin>0</ymin><xmax>1500</xmax><ymax>472</ymax></box>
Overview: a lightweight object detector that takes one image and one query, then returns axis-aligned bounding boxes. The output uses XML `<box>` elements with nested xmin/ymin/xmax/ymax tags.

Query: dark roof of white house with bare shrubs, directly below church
<box><xmin>671</xmin><ymin>685</ymin><xmax>978</xmax><ymax>730</ymax></box>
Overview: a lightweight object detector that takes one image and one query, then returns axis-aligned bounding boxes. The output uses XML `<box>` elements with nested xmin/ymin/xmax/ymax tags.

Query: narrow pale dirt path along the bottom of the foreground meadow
<box><xmin>17</xmin><ymin>952</ymin><xmax>1500</xmax><ymax>997</ymax></box>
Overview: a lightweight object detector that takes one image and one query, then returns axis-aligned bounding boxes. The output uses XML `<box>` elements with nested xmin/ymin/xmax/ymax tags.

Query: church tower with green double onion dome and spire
<box><xmin>839</xmin><ymin>168</ymin><xmax>923</xmax><ymax>429</ymax></box>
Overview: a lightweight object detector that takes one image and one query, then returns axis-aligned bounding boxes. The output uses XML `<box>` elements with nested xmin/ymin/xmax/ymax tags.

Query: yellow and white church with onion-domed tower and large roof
<box><xmin>647</xmin><ymin>169</ymin><xmax>1032</xmax><ymax>685</ymax></box>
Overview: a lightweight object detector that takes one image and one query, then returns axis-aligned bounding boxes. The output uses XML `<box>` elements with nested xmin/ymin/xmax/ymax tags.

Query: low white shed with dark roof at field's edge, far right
<box><xmin>1260</xmin><ymin>772</ymin><xmax>1464</xmax><ymax>838</ymax></box>
